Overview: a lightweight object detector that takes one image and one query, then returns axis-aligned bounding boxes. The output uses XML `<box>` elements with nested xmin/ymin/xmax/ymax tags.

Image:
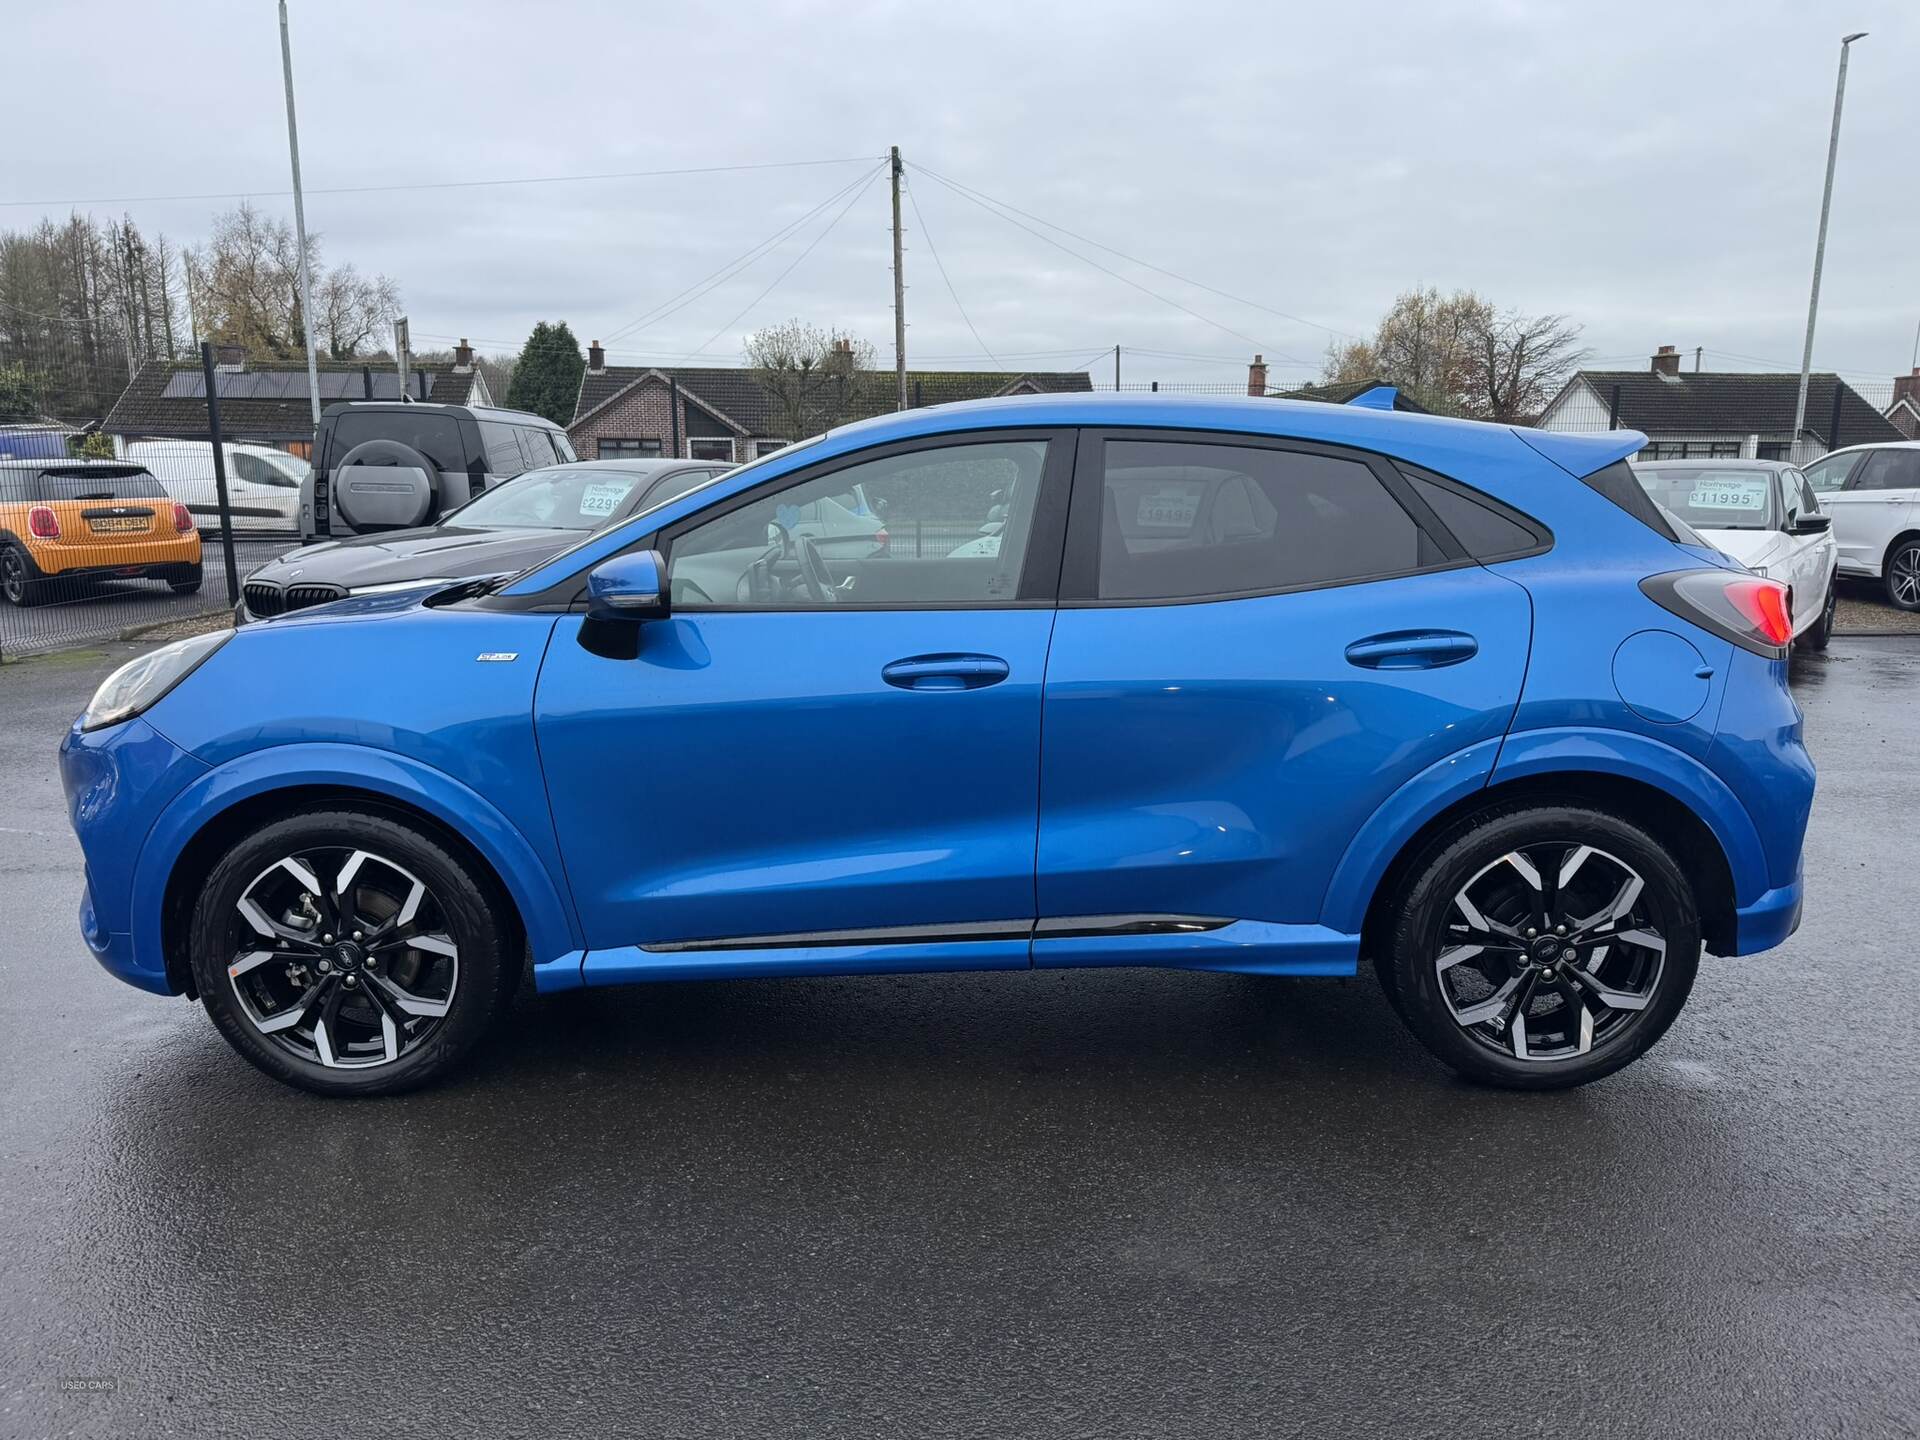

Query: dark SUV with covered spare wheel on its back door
<box><xmin>300</xmin><ymin>401</ymin><xmax>580</xmax><ymax>540</ymax></box>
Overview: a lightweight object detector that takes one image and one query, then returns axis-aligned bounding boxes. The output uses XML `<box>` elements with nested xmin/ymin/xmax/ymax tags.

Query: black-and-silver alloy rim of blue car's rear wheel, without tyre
<box><xmin>1434</xmin><ymin>843</ymin><xmax>1667</xmax><ymax>1062</ymax></box>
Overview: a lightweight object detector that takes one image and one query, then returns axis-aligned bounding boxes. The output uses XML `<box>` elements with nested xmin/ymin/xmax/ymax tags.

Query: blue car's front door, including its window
<box><xmin>536</xmin><ymin>432</ymin><xmax>1071</xmax><ymax>983</ymax></box>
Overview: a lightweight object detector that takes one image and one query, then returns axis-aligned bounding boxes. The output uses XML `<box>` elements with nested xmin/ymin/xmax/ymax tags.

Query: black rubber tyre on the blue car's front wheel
<box><xmin>188</xmin><ymin>808</ymin><xmax>524</xmax><ymax>1096</ymax></box>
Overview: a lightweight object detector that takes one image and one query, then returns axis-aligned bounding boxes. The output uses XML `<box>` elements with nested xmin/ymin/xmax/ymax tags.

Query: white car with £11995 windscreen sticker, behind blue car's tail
<box><xmin>1634</xmin><ymin>461</ymin><xmax>1839</xmax><ymax>651</ymax></box>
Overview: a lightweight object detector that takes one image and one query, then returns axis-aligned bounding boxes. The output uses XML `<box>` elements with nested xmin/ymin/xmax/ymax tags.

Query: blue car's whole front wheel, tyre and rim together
<box><xmin>190</xmin><ymin>810</ymin><xmax>520</xmax><ymax>1094</ymax></box>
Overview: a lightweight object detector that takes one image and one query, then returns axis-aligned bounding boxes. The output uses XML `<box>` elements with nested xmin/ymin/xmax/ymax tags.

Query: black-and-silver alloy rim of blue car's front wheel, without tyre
<box><xmin>227</xmin><ymin>847</ymin><xmax>459</xmax><ymax>1069</ymax></box>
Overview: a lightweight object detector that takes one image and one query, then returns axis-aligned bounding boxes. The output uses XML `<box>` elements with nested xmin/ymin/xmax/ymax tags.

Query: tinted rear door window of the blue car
<box><xmin>1096</xmin><ymin>440</ymin><xmax>1446</xmax><ymax>601</ymax></box>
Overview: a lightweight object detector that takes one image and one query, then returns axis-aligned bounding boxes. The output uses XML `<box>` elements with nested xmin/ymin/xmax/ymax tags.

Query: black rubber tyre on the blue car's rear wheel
<box><xmin>1375</xmin><ymin>803</ymin><xmax>1701</xmax><ymax>1091</ymax></box>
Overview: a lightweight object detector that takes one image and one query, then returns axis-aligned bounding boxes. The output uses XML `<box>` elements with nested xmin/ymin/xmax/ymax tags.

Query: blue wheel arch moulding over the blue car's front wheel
<box><xmin>132</xmin><ymin>747</ymin><xmax>578</xmax><ymax>996</ymax></box>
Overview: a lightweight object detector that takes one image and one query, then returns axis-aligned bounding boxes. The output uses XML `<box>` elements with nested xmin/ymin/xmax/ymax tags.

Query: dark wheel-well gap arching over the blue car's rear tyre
<box><xmin>1361</xmin><ymin>770</ymin><xmax>1738</xmax><ymax>954</ymax></box>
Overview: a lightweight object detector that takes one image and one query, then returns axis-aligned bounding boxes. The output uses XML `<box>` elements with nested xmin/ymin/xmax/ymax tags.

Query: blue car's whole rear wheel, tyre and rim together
<box><xmin>1375</xmin><ymin>804</ymin><xmax>1701</xmax><ymax>1091</ymax></box>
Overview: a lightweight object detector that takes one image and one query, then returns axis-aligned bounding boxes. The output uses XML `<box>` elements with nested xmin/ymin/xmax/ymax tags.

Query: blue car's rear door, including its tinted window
<box><xmin>1035</xmin><ymin>430</ymin><xmax>1532</xmax><ymax>968</ymax></box>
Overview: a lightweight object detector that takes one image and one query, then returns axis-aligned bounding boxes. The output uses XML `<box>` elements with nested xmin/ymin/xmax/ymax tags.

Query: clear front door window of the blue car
<box><xmin>668</xmin><ymin>440</ymin><xmax>1046</xmax><ymax>609</ymax></box>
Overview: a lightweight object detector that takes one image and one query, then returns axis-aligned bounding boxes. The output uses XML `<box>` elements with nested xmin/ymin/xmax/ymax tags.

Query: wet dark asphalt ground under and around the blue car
<box><xmin>0</xmin><ymin>637</ymin><xmax>1920</xmax><ymax>1440</ymax></box>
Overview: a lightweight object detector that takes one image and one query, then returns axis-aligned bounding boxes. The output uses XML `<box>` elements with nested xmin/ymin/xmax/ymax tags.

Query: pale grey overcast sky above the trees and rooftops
<box><xmin>0</xmin><ymin>0</ymin><xmax>1920</xmax><ymax>391</ymax></box>
